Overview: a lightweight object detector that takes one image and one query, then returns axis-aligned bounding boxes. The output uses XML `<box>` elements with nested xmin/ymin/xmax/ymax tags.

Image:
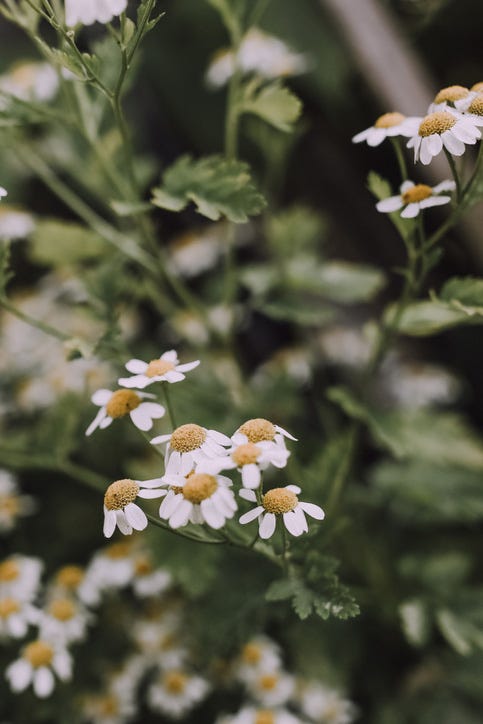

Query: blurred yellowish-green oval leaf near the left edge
<box><xmin>29</xmin><ymin>219</ymin><xmax>107</xmax><ymax>266</ymax></box>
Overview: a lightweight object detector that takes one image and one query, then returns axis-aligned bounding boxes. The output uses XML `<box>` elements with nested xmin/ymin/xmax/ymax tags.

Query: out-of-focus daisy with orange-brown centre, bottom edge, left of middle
<box><xmin>147</xmin><ymin>670</ymin><xmax>210</xmax><ymax>719</ymax></box>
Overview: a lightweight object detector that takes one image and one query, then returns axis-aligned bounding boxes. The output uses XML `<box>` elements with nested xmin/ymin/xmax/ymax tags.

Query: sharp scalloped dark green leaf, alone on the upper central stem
<box><xmin>152</xmin><ymin>156</ymin><xmax>266</xmax><ymax>223</ymax></box>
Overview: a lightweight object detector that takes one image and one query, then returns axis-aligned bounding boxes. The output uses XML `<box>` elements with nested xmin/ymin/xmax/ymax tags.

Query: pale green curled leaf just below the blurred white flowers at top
<box><xmin>241</xmin><ymin>79</ymin><xmax>302</xmax><ymax>133</ymax></box>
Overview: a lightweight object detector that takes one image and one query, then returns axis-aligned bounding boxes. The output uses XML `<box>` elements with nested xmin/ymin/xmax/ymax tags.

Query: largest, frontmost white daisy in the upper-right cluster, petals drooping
<box><xmin>407</xmin><ymin>107</ymin><xmax>481</xmax><ymax>166</ymax></box>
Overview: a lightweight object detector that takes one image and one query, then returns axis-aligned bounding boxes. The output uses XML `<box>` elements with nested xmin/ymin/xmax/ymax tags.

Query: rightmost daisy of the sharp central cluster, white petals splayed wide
<box><xmin>240</xmin><ymin>485</ymin><xmax>325</xmax><ymax>538</ymax></box>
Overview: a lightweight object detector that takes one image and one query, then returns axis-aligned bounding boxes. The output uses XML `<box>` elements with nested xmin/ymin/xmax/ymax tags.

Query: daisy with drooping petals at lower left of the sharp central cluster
<box><xmin>104</xmin><ymin>478</ymin><xmax>164</xmax><ymax>538</ymax></box>
